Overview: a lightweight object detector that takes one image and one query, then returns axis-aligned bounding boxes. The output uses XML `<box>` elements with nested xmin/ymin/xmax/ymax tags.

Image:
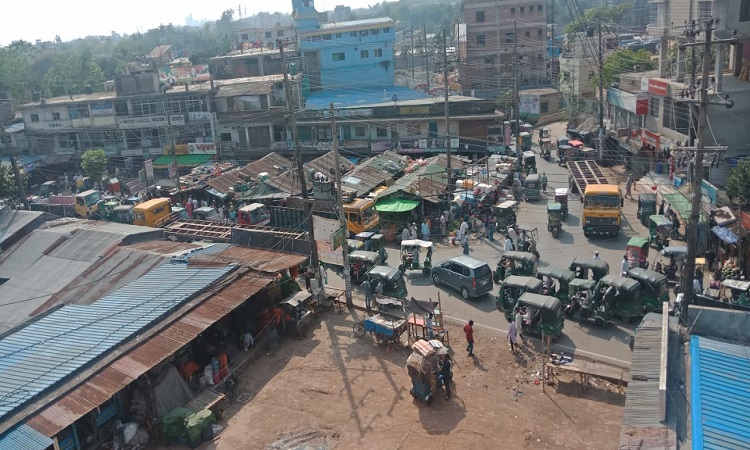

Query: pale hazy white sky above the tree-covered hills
<box><xmin>0</xmin><ymin>0</ymin><xmax>379</xmax><ymax>46</ymax></box>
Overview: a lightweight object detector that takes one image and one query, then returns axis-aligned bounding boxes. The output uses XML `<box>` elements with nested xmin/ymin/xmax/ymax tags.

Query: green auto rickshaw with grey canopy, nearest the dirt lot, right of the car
<box><xmin>505</xmin><ymin>292</ymin><xmax>565</xmax><ymax>341</ymax></box>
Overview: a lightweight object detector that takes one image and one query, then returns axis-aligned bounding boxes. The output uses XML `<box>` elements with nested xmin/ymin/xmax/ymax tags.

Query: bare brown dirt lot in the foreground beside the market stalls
<box><xmin>162</xmin><ymin>311</ymin><xmax>625</xmax><ymax>450</ymax></box>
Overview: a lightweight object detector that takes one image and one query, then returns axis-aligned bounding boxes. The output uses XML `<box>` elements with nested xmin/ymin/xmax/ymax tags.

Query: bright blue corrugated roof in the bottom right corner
<box><xmin>690</xmin><ymin>336</ymin><xmax>750</xmax><ymax>450</ymax></box>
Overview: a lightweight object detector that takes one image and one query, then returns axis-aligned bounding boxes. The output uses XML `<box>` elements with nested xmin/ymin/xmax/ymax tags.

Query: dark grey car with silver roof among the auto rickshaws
<box><xmin>432</xmin><ymin>255</ymin><xmax>493</xmax><ymax>300</ymax></box>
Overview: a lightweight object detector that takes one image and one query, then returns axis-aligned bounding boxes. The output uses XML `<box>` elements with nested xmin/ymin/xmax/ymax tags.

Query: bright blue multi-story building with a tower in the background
<box><xmin>292</xmin><ymin>0</ymin><xmax>396</xmax><ymax>91</ymax></box>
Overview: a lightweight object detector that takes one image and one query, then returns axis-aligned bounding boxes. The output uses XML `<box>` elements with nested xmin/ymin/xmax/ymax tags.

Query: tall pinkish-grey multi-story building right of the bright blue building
<box><xmin>459</xmin><ymin>0</ymin><xmax>547</xmax><ymax>97</ymax></box>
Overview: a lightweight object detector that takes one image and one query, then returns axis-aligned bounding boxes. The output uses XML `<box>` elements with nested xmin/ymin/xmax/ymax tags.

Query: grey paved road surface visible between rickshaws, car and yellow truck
<box><xmin>329</xmin><ymin>122</ymin><xmax>653</xmax><ymax>363</ymax></box>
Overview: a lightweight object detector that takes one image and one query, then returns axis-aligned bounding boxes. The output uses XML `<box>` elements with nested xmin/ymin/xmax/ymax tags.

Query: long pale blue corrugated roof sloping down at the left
<box><xmin>0</xmin><ymin>260</ymin><xmax>232</xmax><ymax>421</ymax></box>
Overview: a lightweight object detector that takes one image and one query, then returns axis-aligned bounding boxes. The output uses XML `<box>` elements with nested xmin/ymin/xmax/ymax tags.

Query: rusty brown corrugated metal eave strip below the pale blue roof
<box><xmin>28</xmin><ymin>272</ymin><xmax>272</xmax><ymax>436</ymax></box>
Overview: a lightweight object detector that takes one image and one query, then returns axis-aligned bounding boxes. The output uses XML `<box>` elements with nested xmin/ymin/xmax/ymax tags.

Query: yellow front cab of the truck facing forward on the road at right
<box><xmin>581</xmin><ymin>184</ymin><xmax>623</xmax><ymax>236</ymax></box>
